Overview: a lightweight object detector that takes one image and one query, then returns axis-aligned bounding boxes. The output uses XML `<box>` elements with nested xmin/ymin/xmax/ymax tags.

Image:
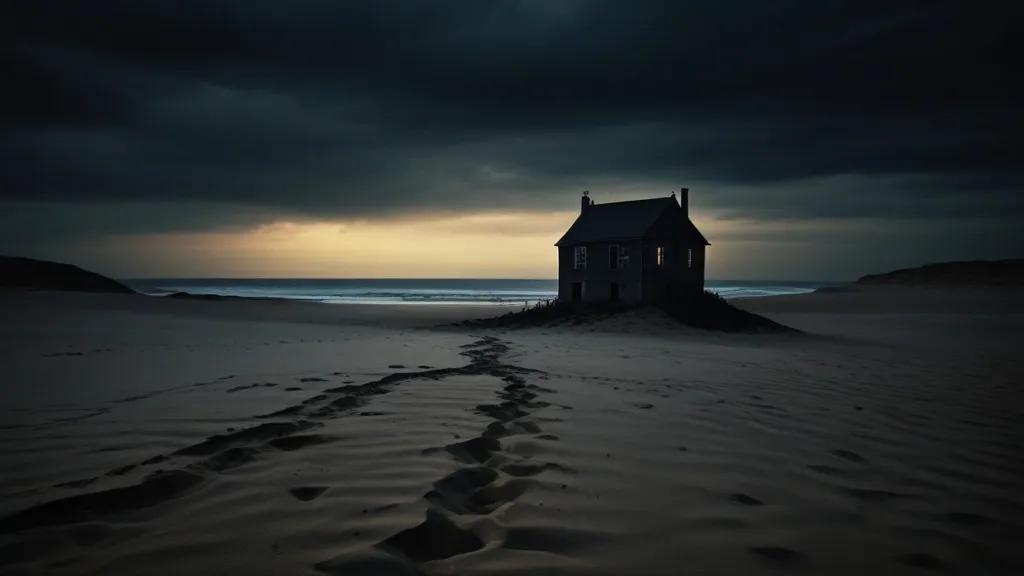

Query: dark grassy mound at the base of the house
<box><xmin>453</xmin><ymin>291</ymin><xmax>798</xmax><ymax>333</ymax></box>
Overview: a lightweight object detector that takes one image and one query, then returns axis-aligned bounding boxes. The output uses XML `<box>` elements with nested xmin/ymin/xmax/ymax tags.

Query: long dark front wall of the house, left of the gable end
<box><xmin>558</xmin><ymin>240</ymin><xmax>646</xmax><ymax>303</ymax></box>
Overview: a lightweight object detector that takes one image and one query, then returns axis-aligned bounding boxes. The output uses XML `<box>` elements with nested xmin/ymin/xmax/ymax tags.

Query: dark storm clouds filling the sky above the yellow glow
<box><xmin>0</xmin><ymin>0</ymin><xmax>1024</xmax><ymax>230</ymax></box>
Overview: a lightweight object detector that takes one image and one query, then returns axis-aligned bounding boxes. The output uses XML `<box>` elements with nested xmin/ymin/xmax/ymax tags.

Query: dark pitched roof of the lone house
<box><xmin>555</xmin><ymin>197</ymin><xmax>711</xmax><ymax>246</ymax></box>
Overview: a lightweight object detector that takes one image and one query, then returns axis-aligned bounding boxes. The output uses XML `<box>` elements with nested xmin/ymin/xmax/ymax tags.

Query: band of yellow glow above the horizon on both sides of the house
<box><xmin>75</xmin><ymin>211</ymin><xmax>835</xmax><ymax>279</ymax></box>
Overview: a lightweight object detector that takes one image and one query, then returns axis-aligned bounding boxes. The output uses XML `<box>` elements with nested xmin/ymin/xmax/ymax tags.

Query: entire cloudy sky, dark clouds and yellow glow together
<box><xmin>0</xmin><ymin>0</ymin><xmax>1024</xmax><ymax>280</ymax></box>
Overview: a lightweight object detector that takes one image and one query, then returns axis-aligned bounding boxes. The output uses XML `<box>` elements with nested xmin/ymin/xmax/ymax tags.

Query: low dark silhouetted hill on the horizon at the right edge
<box><xmin>854</xmin><ymin>258</ymin><xmax>1024</xmax><ymax>286</ymax></box>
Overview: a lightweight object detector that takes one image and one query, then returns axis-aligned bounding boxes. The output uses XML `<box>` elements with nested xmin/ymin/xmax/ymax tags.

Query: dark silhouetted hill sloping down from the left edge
<box><xmin>0</xmin><ymin>256</ymin><xmax>136</xmax><ymax>294</ymax></box>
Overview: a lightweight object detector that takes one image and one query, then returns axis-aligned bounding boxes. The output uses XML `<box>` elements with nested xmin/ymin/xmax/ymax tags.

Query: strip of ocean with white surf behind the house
<box><xmin>122</xmin><ymin>278</ymin><xmax>836</xmax><ymax>305</ymax></box>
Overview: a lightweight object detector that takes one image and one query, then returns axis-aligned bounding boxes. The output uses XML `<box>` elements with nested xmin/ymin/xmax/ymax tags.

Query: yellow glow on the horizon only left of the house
<box><xmin>89</xmin><ymin>212</ymin><xmax>577</xmax><ymax>278</ymax></box>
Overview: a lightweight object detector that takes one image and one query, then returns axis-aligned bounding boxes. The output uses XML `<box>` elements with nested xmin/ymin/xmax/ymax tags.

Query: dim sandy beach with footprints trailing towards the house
<box><xmin>0</xmin><ymin>287</ymin><xmax>1024</xmax><ymax>575</ymax></box>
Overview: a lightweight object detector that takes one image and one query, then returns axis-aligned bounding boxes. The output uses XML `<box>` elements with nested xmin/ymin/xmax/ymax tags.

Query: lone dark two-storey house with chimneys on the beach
<box><xmin>555</xmin><ymin>188</ymin><xmax>711</xmax><ymax>303</ymax></box>
